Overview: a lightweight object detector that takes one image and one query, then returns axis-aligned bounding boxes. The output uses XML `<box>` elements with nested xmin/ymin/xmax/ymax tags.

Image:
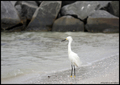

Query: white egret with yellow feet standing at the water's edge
<box><xmin>62</xmin><ymin>36</ymin><xmax>82</xmax><ymax>77</ymax></box>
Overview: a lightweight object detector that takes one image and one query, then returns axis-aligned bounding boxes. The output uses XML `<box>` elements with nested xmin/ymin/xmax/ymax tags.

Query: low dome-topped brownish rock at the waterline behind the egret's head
<box><xmin>52</xmin><ymin>16</ymin><xmax>84</xmax><ymax>32</ymax></box>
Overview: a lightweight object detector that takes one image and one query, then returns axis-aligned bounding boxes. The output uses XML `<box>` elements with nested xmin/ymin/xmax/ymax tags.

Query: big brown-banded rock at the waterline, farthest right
<box><xmin>85</xmin><ymin>10</ymin><xmax>119</xmax><ymax>33</ymax></box>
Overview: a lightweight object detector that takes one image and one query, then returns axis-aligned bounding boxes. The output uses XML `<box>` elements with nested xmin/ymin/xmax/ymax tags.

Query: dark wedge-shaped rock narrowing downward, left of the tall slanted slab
<box><xmin>12</xmin><ymin>1</ymin><xmax>38</xmax><ymax>31</ymax></box>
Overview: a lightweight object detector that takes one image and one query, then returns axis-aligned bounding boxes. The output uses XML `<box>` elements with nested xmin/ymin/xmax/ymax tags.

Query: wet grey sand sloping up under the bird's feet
<box><xmin>24</xmin><ymin>55</ymin><xmax>119</xmax><ymax>84</ymax></box>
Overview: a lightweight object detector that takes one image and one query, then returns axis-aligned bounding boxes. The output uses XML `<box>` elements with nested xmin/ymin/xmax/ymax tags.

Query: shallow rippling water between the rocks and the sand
<box><xmin>1</xmin><ymin>32</ymin><xmax>119</xmax><ymax>81</ymax></box>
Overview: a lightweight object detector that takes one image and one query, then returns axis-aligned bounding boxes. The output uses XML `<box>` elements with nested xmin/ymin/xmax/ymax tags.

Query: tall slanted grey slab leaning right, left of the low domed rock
<box><xmin>26</xmin><ymin>1</ymin><xmax>61</xmax><ymax>31</ymax></box>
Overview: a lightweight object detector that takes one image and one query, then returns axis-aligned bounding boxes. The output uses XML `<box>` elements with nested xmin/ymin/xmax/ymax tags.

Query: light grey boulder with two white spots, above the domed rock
<box><xmin>61</xmin><ymin>1</ymin><xmax>109</xmax><ymax>20</ymax></box>
